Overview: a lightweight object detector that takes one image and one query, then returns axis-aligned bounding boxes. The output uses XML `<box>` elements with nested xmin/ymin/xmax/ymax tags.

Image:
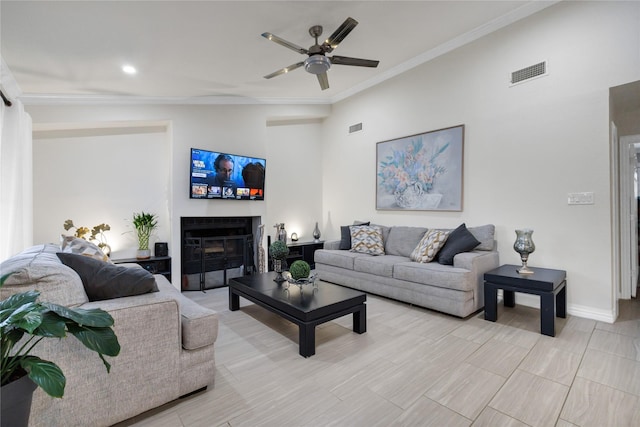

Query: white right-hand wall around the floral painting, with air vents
<box><xmin>323</xmin><ymin>2</ymin><xmax>640</xmax><ymax>320</ymax></box>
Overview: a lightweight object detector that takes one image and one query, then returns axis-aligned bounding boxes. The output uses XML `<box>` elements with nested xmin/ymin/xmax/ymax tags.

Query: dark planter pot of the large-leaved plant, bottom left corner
<box><xmin>0</xmin><ymin>375</ymin><xmax>37</xmax><ymax>427</ymax></box>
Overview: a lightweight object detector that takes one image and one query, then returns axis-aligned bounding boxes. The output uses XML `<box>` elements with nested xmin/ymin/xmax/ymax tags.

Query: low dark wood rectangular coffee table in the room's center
<box><xmin>229</xmin><ymin>272</ymin><xmax>367</xmax><ymax>357</ymax></box>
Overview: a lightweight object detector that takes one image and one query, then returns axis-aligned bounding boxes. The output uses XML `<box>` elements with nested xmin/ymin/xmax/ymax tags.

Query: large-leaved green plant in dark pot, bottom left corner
<box><xmin>0</xmin><ymin>273</ymin><xmax>120</xmax><ymax>426</ymax></box>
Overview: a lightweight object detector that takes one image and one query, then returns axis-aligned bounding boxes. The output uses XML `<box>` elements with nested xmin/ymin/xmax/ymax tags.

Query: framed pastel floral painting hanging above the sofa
<box><xmin>376</xmin><ymin>125</ymin><xmax>464</xmax><ymax>211</ymax></box>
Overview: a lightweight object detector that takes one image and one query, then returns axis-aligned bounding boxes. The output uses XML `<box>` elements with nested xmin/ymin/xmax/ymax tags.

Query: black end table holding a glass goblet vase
<box><xmin>484</xmin><ymin>264</ymin><xmax>567</xmax><ymax>337</ymax></box>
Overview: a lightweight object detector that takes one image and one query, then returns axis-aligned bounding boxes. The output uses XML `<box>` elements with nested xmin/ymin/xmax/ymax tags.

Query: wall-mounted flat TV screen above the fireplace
<box><xmin>189</xmin><ymin>148</ymin><xmax>266</xmax><ymax>200</ymax></box>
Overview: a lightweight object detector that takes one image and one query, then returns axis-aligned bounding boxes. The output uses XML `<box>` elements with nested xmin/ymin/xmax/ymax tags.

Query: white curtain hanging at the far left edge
<box><xmin>0</xmin><ymin>61</ymin><xmax>33</xmax><ymax>260</ymax></box>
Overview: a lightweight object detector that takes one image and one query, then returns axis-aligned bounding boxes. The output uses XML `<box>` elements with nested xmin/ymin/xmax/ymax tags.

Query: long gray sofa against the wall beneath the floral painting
<box><xmin>314</xmin><ymin>224</ymin><xmax>499</xmax><ymax>317</ymax></box>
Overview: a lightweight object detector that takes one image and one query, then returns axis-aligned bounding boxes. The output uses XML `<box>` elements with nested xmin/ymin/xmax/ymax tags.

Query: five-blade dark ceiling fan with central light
<box><xmin>262</xmin><ymin>18</ymin><xmax>380</xmax><ymax>90</ymax></box>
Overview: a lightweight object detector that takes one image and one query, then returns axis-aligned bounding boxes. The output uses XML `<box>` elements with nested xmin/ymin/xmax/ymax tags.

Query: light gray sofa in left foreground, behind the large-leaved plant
<box><xmin>0</xmin><ymin>244</ymin><xmax>218</xmax><ymax>426</ymax></box>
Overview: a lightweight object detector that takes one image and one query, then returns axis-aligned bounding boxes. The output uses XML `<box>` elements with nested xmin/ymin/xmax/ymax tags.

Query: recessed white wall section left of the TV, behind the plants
<box><xmin>33</xmin><ymin>124</ymin><xmax>171</xmax><ymax>258</ymax></box>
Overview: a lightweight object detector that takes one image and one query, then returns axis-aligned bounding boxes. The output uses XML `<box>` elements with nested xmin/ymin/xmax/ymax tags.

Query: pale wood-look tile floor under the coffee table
<box><xmin>118</xmin><ymin>288</ymin><xmax>640</xmax><ymax>427</ymax></box>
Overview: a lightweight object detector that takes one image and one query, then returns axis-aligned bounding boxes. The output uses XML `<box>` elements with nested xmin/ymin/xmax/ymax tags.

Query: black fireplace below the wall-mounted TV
<box><xmin>180</xmin><ymin>217</ymin><xmax>260</xmax><ymax>291</ymax></box>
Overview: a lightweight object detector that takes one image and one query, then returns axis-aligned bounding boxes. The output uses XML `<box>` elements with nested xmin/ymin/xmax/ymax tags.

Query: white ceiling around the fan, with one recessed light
<box><xmin>0</xmin><ymin>0</ymin><xmax>555</xmax><ymax>103</ymax></box>
